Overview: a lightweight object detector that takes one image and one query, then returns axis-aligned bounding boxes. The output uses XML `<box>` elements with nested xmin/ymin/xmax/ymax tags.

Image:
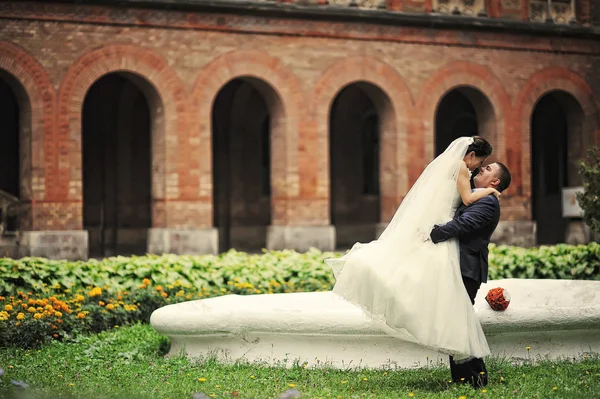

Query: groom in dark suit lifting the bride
<box><xmin>430</xmin><ymin>162</ymin><xmax>511</xmax><ymax>388</ymax></box>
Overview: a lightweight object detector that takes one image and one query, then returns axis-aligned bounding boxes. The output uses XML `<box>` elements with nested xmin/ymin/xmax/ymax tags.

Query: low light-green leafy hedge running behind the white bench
<box><xmin>0</xmin><ymin>243</ymin><xmax>600</xmax><ymax>295</ymax></box>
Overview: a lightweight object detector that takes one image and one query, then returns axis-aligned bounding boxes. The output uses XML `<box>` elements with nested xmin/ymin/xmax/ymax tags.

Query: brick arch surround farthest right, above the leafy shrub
<box><xmin>511</xmin><ymin>67</ymin><xmax>600</xmax><ymax>203</ymax></box>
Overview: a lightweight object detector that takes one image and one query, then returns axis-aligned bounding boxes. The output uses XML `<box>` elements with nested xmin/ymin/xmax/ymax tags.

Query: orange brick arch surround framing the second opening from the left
<box><xmin>57</xmin><ymin>44</ymin><xmax>194</xmax><ymax>228</ymax></box>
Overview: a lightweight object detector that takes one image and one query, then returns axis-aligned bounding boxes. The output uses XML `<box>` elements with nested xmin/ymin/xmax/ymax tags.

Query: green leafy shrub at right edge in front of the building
<box><xmin>577</xmin><ymin>147</ymin><xmax>600</xmax><ymax>234</ymax></box>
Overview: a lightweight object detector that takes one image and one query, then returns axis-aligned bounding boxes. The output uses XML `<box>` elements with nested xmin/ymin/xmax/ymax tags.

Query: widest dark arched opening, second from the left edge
<box><xmin>82</xmin><ymin>72</ymin><xmax>155</xmax><ymax>257</ymax></box>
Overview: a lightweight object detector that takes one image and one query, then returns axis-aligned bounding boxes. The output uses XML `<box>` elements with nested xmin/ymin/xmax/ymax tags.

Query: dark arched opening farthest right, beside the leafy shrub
<box><xmin>531</xmin><ymin>91</ymin><xmax>585</xmax><ymax>244</ymax></box>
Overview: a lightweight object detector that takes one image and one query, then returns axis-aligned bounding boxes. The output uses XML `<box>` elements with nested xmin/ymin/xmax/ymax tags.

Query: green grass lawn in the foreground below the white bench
<box><xmin>0</xmin><ymin>325</ymin><xmax>600</xmax><ymax>399</ymax></box>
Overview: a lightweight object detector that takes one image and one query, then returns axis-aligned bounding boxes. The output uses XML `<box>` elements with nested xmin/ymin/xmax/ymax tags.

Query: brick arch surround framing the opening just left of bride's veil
<box><xmin>312</xmin><ymin>57</ymin><xmax>413</xmax><ymax>222</ymax></box>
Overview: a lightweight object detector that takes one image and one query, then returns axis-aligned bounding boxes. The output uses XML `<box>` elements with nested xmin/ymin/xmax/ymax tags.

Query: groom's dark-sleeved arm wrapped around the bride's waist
<box><xmin>430</xmin><ymin>196</ymin><xmax>496</xmax><ymax>244</ymax></box>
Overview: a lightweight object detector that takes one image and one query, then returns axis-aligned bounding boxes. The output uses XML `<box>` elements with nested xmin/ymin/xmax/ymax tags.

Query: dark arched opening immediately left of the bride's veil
<box><xmin>329</xmin><ymin>82</ymin><xmax>384</xmax><ymax>249</ymax></box>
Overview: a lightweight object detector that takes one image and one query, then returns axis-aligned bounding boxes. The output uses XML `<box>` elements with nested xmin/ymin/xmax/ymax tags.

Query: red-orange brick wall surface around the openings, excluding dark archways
<box><xmin>0</xmin><ymin>1</ymin><xmax>600</xmax><ymax>234</ymax></box>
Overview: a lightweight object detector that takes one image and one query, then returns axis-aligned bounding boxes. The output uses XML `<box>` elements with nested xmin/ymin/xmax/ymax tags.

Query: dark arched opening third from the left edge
<box><xmin>212</xmin><ymin>77</ymin><xmax>276</xmax><ymax>252</ymax></box>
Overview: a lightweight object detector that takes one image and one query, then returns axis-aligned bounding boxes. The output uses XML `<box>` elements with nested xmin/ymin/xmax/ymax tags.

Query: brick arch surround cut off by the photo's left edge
<box><xmin>0</xmin><ymin>42</ymin><xmax>56</xmax><ymax>230</ymax></box>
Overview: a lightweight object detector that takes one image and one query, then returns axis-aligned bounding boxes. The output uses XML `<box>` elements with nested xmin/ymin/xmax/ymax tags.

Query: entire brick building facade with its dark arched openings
<box><xmin>0</xmin><ymin>0</ymin><xmax>600</xmax><ymax>259</ymax></box>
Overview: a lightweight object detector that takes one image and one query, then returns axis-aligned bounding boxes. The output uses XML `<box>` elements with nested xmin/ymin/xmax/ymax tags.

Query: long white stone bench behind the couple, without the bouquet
<box><xmin>150</xmin><ymin>279</ymin><xmax>600</xmax><ymax>368</ymax></box>
